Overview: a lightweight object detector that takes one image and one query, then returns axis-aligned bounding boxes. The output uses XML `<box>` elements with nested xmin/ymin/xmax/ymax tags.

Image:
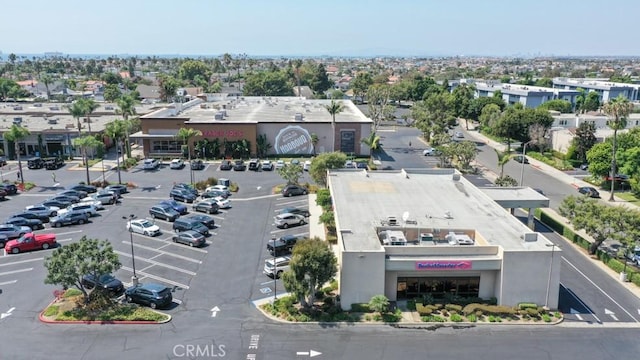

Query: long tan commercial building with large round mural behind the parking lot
<box><xmin>136</xmin><ymin>94</ymin><xmax>372</xmax><ymax>158</ymax></box>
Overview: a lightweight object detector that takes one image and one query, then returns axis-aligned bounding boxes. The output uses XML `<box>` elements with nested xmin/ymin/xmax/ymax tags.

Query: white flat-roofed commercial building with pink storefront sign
<box><xmin>328</xmin><ymin>169</ymin><xmax>561</xmax><ymax>309</ymax></box>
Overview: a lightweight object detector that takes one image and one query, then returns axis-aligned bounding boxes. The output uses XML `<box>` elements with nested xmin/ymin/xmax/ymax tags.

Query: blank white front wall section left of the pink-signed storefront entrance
<box><xmin>340</xmin><ymin>251</ymin><xmax>385</xmax><ymax>310</ymax></box>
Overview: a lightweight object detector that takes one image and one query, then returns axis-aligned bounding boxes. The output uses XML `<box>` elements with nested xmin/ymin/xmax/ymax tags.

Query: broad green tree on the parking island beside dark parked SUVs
<box><xmin>44</xmin><ymin>235</ymin><xmax>121</xmax><ymax>303</ymax></box>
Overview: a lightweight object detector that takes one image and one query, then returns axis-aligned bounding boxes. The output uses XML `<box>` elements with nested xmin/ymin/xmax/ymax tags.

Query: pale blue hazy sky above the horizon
<box><xmin>0</xmin><ymin>0</ymin><xmax>640</xmax><ymax>57</ymax></box>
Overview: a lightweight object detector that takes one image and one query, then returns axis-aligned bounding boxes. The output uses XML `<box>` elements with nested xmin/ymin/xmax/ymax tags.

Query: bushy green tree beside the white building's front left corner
<box><xmin>282</xmin><ymin>238</ymin><xmax>338</xmax><ymax>308</ymax></box>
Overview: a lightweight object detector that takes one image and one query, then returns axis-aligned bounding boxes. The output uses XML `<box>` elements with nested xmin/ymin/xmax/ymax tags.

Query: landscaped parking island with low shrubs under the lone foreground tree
<box><xmin>39</xmin><ymin>289</ymin><xmax>171</xmax><ymax>324</ymax></box>
